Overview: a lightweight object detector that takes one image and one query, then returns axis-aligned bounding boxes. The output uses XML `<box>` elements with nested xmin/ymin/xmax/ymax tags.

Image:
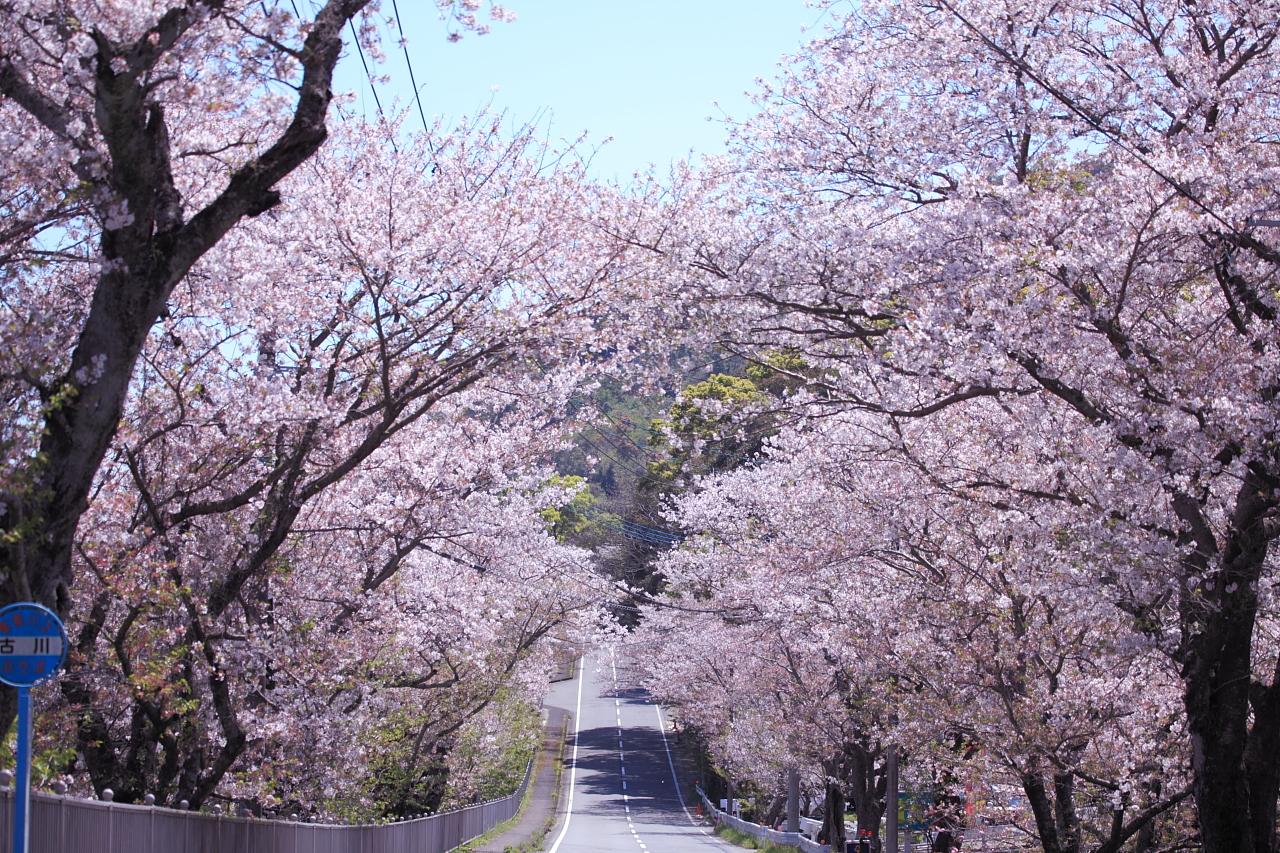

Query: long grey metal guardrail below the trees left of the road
<box><xmin>0</xmin><ymin>766</ymin><xmax>532</xmax><ymax>853</ymax></box>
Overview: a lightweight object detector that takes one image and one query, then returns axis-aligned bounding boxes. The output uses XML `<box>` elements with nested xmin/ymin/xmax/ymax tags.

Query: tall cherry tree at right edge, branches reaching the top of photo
<box><xmin>640</xmin><ymin>1</ymin><xmax>1280</xmax><ymax>852</ymax></box>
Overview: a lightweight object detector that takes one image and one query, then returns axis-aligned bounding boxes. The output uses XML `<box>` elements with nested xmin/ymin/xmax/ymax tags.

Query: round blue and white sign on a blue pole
<box><xmin>0</xmin><ymin>602</ymin><xmax>67</xmax><ymax>853</ymax></box>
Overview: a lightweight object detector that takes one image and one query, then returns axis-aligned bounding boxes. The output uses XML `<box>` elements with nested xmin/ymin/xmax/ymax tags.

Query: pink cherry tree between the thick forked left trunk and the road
<box><xmin>31</xmin><ymin>115</ymin><xmax>645</xmax><ymax>803</ymax></box>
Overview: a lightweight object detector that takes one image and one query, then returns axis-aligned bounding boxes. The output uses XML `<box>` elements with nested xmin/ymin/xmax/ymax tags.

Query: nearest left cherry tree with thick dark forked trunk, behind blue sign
<box><xmin>0</xmin><ymin>0</ymin><xmax>519</xmax><ymax>721</ymax></box>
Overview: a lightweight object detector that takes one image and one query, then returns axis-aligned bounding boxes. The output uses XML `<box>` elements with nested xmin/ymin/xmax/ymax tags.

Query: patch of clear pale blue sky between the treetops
<box><xmin>338</xmin><ymin>0</ymin><xmax>822</xmax><ymax>181</ymax></box>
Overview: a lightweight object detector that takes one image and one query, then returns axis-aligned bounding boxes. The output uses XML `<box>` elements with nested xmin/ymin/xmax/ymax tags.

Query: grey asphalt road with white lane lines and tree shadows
<box><xmin>547</xmin><ymin>652</ymin><xmax>739</xmax><ymax>853</ymax></box>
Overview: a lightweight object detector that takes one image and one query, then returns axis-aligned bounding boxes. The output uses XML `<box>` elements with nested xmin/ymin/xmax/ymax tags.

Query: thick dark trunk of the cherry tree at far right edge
<box><xmin>1020</xmin><ymin>338</ymin><xmax>1280</xmax><ymax>853</ymax></box>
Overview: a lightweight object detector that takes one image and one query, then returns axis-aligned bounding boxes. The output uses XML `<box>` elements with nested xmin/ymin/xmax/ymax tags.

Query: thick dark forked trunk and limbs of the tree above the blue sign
<box><xmin>0</xmin><ymin>0</ymin><xmax>369</xmax><ymax>727</ymax></box>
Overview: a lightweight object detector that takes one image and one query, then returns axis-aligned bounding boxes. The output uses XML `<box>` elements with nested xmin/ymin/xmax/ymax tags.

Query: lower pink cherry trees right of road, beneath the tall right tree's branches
<box><xmin>646</xmin><ymin>399</ymin><xmax>1190</xmax><ymax>853</ymax></box>
